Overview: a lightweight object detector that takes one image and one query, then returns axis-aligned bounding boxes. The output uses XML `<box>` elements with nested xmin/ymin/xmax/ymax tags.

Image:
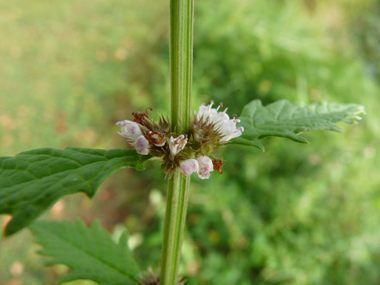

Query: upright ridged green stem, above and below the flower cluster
<box><xmin>160</xmin><ymin>0</ymin><xmax>194</xmax><ymax>285</ymax></box>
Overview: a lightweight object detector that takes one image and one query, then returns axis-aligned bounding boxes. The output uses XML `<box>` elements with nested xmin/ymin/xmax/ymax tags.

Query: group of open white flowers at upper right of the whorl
<box><xmin>197</xmin><ymin>101</ymin><xmax>244</xmax><ymax>142</ymax></box>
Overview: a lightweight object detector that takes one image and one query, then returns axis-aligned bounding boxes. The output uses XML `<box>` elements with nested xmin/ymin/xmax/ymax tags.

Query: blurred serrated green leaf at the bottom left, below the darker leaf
<box><xmin>29</xmin><ymin>220</ymin><xmax>140</xmax><ymax>285</ymax></box>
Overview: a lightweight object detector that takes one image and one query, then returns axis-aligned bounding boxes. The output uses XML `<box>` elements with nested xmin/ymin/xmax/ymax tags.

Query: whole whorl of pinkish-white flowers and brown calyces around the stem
<box><xmin>116</xmin><ymin>101</ymin><xmax>244</xmax><ymax>179</ymax></box>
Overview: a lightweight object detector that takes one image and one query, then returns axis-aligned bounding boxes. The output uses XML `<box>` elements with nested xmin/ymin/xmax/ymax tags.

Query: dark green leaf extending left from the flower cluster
<box><xmin>0</xmin><ymin>147</ymin><xmax>150</xmax><ymax>235</ymax></box>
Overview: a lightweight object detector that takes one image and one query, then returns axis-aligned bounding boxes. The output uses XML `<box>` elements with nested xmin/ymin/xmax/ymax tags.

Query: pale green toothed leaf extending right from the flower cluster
<box><xmin>231</xmin><ymin>100</ymin><xmax>365</xmax><ymax>151</ymax></box>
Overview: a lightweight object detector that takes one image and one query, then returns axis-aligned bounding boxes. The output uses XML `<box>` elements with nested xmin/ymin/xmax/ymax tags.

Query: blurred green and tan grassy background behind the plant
<box><xmin>0</xmin><ymin>0</ymin><xmax>380</xmax><ymax>285</ymax></box>
